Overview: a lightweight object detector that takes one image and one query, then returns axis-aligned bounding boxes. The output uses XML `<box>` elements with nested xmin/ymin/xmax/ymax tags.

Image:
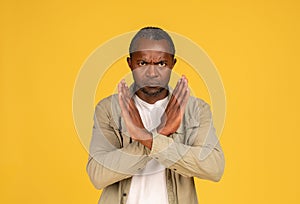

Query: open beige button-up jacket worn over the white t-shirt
<box><xmin>87</xmin><ymin>89</ymin><xmax>224</xmax><ymax>204</ymax></box>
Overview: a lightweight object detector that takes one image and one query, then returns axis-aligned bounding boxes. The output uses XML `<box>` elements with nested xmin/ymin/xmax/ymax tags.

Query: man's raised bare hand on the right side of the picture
<box><xmin>157</xmin><ymin>76</ymin><xmax>190</xmax><ymax>136</ymax></box>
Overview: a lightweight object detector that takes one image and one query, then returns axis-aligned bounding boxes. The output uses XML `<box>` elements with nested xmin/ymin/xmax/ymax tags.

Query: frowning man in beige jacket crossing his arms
<box><xmin>87</xmin><ymin>27</ymin><xmax>224</xmax><ymax>204</ymax></box>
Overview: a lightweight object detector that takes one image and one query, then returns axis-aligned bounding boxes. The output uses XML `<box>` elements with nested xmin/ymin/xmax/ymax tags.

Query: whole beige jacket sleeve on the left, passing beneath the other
<box><xmin>86</xmin><ymin>99</ymin><xmax>149</xmax><ymax>189</ymax></box>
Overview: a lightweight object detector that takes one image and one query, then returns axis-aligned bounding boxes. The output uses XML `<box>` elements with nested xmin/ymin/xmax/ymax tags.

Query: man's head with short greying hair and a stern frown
<box><xmin>127</xmin><ymin>27</ymin><xmax>176</xmax><ymax>101</ymax></box>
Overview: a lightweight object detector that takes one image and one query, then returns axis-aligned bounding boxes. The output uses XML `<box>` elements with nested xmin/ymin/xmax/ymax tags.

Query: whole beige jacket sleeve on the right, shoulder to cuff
<box><xmin>149</xmin><ymin>99</ymin><xmax>225</xmax><ymax>181</ymax></box>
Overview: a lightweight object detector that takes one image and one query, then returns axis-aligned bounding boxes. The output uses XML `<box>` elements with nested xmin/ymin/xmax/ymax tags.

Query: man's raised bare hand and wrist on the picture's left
<box><xmin>118</xmin><ymin>80</ymin><xmax>152</xmax><ymax>149</ymax></box>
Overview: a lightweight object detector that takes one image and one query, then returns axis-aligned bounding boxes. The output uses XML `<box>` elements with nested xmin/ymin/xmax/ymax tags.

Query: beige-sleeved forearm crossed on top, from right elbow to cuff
<box><xmin>149</xmin><ymin>135</ymin><xmax>224</xmax><ymax>181</ymax></box>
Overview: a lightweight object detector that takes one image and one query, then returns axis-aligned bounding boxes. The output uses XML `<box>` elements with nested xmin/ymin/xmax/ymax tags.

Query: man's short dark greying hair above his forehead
<box><xmin>129</xmin><ymin>26</ymin><xmax>175</xmax><ymax>56</ymax></box>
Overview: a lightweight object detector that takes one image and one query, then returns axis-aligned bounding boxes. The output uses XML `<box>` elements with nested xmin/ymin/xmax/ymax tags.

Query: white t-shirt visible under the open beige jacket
<box><xmin>127</xmin><ymin>95</ymin><xmax>169</xmax><ymax>204</ymax></box>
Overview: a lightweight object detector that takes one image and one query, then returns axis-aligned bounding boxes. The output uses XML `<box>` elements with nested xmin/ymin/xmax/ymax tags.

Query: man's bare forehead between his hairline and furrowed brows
<box><xmin>133</xmin><ymin>38</ymin><xmax>171</xmax><ymax>54</ymax></box>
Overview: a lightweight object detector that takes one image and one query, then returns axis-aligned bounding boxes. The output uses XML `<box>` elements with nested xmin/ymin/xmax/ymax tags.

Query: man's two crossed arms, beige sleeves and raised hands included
<box><xmin>87</xmin><ymin>78</ymin><xmax>224</xmax><ymax>189</ymax></box>
